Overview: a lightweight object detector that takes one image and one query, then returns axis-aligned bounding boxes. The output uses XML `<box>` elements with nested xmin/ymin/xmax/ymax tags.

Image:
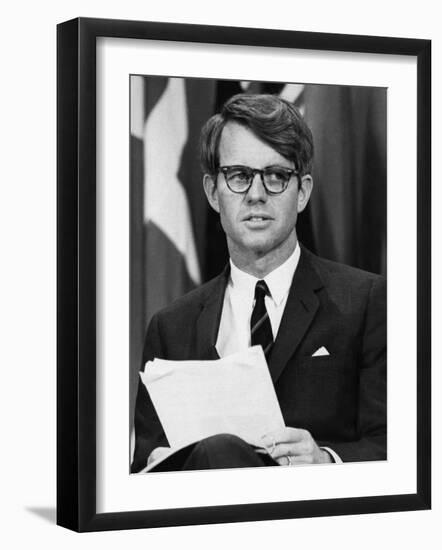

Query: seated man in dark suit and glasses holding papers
<box><xmin>132</xmin><ymin>94</ymin><xmax>386</xmax><ymax>472</ymax></box>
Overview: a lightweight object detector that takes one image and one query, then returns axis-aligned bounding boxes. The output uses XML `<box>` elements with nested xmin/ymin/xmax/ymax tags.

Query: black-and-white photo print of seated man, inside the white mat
<box><xmin>129</xmin><ymin>75</ymin><xmax>388</xmax><ymax>474</ymax></box>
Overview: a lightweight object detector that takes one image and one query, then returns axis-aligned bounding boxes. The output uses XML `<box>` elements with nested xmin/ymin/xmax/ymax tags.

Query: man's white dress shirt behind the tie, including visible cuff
<box><xmin>216</xmin><ymin>243</ymin><xmax>342</xmax><ymax>464</ymax></box>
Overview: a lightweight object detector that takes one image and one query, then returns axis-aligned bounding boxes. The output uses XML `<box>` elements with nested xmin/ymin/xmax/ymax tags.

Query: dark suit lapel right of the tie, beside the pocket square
<box><xmin>269</xmin><ymin>248</ymin><xmax>323</xmax><ymax>383</ymax></box>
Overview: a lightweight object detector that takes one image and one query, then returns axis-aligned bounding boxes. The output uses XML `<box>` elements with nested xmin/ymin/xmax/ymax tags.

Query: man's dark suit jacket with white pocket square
<box><xmin>132</xmin><ymin>247</ymin><xmax>386</xmax><ymax>472</ymax></box>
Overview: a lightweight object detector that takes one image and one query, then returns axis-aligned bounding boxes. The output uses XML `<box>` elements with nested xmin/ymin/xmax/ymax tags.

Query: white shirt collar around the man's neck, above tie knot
<box><xmin>229</xmin><ymin>243</ymin><xmax>301</xmax><ymax>306</ymax></box>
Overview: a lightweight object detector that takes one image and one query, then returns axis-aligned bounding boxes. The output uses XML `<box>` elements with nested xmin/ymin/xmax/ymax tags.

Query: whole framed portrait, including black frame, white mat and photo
<box><xmin>53</xmin><ymin>18</ymin><xmax>431</xmax><ymax>531</ymax></box>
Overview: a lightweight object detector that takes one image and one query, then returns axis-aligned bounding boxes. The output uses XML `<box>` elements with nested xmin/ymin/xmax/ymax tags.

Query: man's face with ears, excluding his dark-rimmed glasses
<box><xmin>204</xmin><ymin>122</ymin><xmax>312</xmax><ymax>269</ymax></box>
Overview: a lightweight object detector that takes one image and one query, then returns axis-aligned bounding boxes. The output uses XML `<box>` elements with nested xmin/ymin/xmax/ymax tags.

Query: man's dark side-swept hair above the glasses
<box><xmin>200</xmin><ymin>94</ymin><xmax>313</xmax><ymax>176</ymax></box>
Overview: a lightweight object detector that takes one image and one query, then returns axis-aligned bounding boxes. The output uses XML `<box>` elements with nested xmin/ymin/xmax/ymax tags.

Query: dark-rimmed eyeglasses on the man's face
<box><xmin>218</xmin><ymin>166</ymin><xmax>299</xmax><ymax>195</ymax></box>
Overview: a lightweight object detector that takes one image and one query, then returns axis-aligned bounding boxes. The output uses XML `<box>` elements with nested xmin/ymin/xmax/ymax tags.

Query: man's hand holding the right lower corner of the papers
<box><xmin>262</xmin><ymin>428</ymin><xmax>332</xmax><ymax>466</ymax></box>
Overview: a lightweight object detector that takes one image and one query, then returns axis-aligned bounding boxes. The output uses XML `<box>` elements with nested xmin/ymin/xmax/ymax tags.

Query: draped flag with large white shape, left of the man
<box><xmin>130</xmin><ymin>76</ymin><xmax>215</xmax><ymax>440</ymax></box>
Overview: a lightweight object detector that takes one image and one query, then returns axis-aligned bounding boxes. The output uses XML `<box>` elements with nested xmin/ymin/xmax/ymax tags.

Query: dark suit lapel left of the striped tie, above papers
<box><xmin>196</xmin><ymin>266</ymin><xmax>229</xmax><ymax>360</ymax></box>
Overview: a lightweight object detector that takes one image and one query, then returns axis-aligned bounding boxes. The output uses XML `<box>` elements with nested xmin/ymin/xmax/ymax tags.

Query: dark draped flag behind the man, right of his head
<box><xmin>304</xmin><ymin>85</ymin><xmax>387</xmax><ymax>275</ymax></box>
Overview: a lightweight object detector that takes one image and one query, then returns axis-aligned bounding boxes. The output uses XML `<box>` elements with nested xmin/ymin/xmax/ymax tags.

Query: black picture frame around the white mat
<box><xmin>57</xmin><ymin>18</ymin><xmax>431</xmax><ymax>532</ymax></box>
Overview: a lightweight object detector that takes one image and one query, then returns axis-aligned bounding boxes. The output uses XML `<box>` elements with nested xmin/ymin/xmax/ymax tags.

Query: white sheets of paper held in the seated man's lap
<box><xmin>140</xmin><ymin>346</ymin><xmax>284</xmax><ymax>448</ymax></box>
